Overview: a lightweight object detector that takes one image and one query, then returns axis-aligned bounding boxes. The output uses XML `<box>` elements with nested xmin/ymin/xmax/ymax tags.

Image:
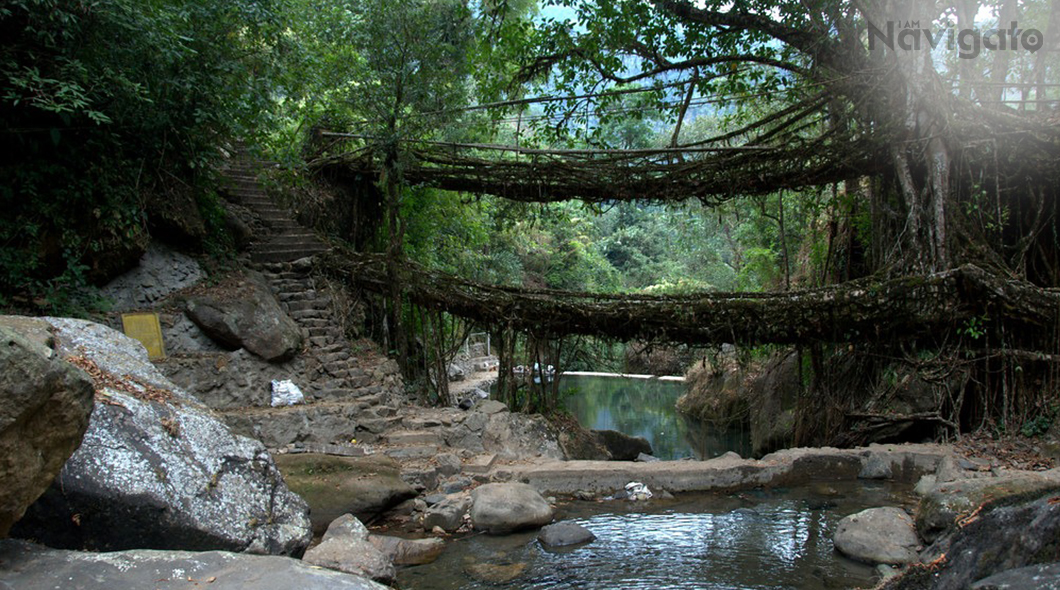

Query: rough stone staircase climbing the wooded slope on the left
<box><xmin>210</xmin><ymin>155</ymin><xmax>405</xmax><ymax>448</ymax></box>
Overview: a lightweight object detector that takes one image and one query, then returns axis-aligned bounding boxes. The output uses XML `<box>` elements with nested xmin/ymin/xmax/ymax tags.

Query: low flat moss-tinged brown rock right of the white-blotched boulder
<box><xmin>276</xmin><ymin>453</ymin><xmax>418</xmax><ymax>535</ymax></box>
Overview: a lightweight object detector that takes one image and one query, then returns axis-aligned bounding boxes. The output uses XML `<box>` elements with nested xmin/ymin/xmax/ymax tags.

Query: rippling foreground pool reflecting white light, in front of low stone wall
<box><xmin>399</xmin><ymin>482</ymin><xmax>911</xmax><ymax>590</ymax></box>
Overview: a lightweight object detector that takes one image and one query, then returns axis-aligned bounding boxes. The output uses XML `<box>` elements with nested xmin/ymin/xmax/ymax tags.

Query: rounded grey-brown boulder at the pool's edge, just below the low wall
<box><xmin>471</xmin><ymin>483</ymin><xmax>552</xmax><ymax>535</ymax></box>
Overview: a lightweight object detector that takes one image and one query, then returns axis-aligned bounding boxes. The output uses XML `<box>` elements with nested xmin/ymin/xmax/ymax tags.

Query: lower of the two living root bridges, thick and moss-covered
<box><xmin>318</xmin><ymin>249</ymin><xmax>1060</xmax><ymax>352</ymax></box>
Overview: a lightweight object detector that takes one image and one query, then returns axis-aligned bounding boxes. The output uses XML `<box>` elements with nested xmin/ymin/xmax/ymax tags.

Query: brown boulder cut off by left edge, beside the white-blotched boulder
<box><xmin>0</xmin><ymin>317</ymin><xmax>94</xmax><ymax>537</ymax></box>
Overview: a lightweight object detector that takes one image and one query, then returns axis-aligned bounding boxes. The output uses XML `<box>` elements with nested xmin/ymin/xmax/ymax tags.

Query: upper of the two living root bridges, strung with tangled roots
<box><xmin>315</xmin><ymin>133</ymin><xmax>883</xmax><ymax>204</ymax></box>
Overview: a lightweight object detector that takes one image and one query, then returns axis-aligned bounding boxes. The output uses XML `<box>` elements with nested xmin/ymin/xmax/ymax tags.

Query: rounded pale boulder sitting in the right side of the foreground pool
<box><xmin>833</xmin><ymin>506</ymin><xmax>919</xmax><ymax>565</ymax></box>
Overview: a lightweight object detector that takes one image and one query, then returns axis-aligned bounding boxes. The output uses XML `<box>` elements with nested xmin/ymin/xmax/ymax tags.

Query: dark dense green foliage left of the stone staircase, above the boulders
<box><xmin>0</xmin><ymin>0</ymin><xmax>281</xmax><ymax>311</ymax></box>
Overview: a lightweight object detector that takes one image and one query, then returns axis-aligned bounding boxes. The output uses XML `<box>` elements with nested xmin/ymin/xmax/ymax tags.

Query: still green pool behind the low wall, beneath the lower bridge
<box><xmin>560</xmin><ymin>375</ymin><xmax>750</xmax><ymax>460</ymax></box>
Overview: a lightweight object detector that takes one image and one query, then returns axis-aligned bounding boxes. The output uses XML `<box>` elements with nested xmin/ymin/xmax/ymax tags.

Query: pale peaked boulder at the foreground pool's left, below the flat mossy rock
<box><xmin>302</xmin><ymin>514</ymin><xmax>398</xmax><ymax>584</ymax></box>
